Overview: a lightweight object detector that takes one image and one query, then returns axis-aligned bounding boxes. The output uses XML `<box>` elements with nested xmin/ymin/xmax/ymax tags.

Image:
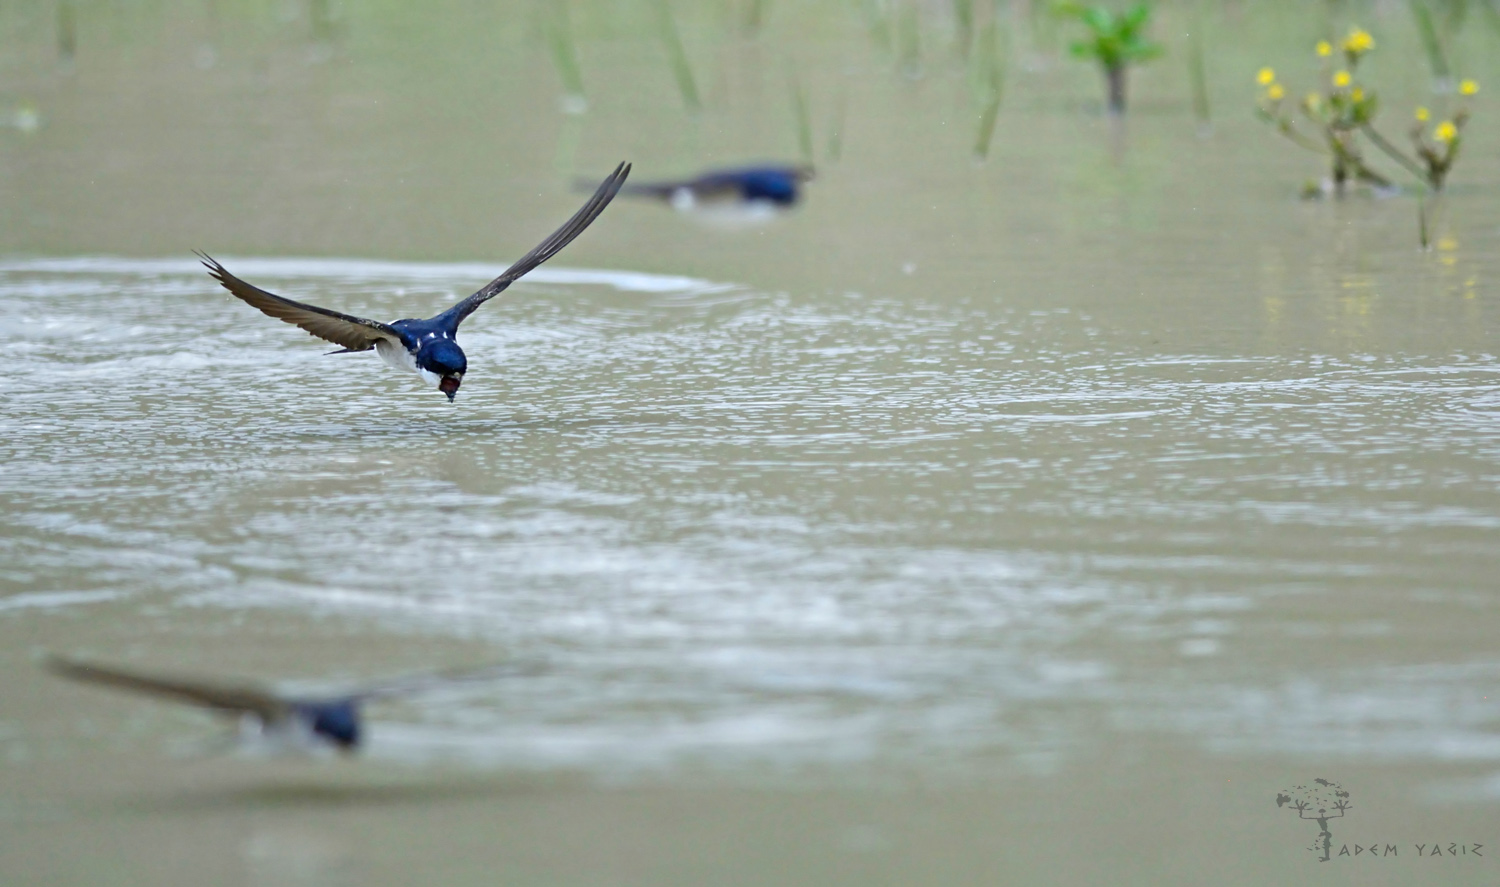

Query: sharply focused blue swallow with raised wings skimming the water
<box><xmin>198</xmin><ymin>164</ymin><xmax>630</xmax><ymax>402</ymax></box>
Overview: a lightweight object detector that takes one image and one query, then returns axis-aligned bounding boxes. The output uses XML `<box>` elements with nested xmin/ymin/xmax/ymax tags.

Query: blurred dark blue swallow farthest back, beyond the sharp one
<box><xmin>621</xmin><ymin>164</ymin><xmax>813</xmax><ymax>224</ymax></box>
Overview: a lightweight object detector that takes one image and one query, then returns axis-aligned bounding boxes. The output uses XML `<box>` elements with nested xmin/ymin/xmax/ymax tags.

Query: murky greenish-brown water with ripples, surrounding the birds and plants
<box><xmin>0</xmin><ymin>3</ymin><xmax>1500</xmax><ymax>884</ymax></box>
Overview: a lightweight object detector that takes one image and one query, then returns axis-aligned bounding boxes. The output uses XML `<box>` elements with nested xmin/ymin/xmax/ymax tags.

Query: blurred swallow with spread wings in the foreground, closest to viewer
<box><xmin>42</xmin><ymin>654</ymin><xmax>534</xmax><ymax>753</ymax></box>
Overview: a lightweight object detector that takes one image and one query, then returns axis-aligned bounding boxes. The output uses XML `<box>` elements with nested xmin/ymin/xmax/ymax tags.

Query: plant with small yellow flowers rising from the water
<box><xmin>1256</xmin><ymin>27</ymin><xmax>1479</xmax><ymax>194</ymax></box>
